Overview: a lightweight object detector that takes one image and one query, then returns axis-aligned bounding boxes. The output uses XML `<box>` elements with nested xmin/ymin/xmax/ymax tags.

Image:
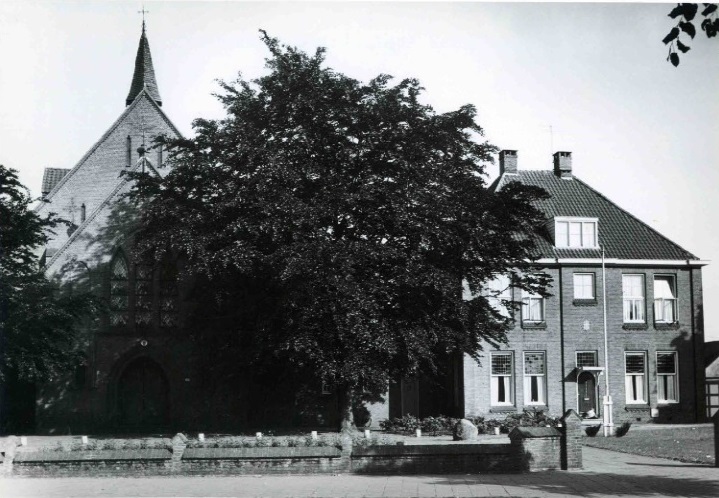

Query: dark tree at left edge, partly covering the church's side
<box><xmin>0</xmin><ymin>165</ymin><xmax>99</xmax><ymax>381</ymax></box>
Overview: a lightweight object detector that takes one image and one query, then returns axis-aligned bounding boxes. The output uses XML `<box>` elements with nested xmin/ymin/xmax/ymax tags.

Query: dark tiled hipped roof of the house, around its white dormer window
<box><xmin>492</xmin><ymin>171</ymin><xmax>698</xmax><ymax>260</ymax></box>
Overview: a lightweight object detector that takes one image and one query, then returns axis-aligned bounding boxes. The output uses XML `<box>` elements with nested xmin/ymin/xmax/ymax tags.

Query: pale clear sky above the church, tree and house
<box><xmin>0</xmin><ymin>0</ymin><xmax>719</xmax><ymax>340</ymax></box>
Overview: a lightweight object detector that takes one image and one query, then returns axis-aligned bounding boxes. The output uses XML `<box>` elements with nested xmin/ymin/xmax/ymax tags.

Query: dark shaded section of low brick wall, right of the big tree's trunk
<box><xmin>351</xmin><ymin>443</ymin><xmax>518</xmax><ymax>474</ymax></box>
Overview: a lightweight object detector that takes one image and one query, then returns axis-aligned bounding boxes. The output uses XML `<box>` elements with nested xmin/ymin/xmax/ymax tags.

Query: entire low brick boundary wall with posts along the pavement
<box><xmin>2</xmin><ymin>410</ymin><xmax>582</xmax><ymax>477</ymax></box>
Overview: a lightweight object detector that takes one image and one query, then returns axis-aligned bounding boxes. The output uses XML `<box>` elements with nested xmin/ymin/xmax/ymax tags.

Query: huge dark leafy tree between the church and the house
<box><xmin>126</xmin><ymin>32</ymin><xmax>546</xmax><ymax>428</ymax></box>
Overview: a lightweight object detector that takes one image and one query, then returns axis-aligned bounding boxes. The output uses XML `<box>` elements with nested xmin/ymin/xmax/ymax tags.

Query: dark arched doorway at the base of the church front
<box><xmin>117</xmin><ymin>357</ymin><xmax>170</xmax><ymax>432</ymax></box>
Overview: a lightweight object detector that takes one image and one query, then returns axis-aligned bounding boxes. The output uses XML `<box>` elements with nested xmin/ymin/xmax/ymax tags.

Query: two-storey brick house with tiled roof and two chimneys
<box><xmin>464</xmin><ymin>151</ymin><xmax>705</xmax><ymax>424</ymax></box>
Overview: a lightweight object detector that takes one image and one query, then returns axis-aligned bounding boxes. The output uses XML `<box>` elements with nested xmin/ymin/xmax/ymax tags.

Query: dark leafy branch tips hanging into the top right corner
<box><xmin>662</xmin><ymin>3</ymin><xmax>719</xmax><ymax>67</ymax></box>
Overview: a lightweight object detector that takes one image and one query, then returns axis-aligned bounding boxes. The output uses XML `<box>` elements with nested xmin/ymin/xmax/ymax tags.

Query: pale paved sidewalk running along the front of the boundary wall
<box><xmin>0</xmin><ymin>447</ymin><xmax>719</xmax><ymax>498</ymax></box>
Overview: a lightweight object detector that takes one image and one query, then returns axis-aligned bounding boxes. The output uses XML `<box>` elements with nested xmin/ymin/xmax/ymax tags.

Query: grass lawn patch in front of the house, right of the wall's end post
<box><xmin>583</xmin><ymin>427</ymin><xmax>714</xmax><ymax>465</ymax></box>
